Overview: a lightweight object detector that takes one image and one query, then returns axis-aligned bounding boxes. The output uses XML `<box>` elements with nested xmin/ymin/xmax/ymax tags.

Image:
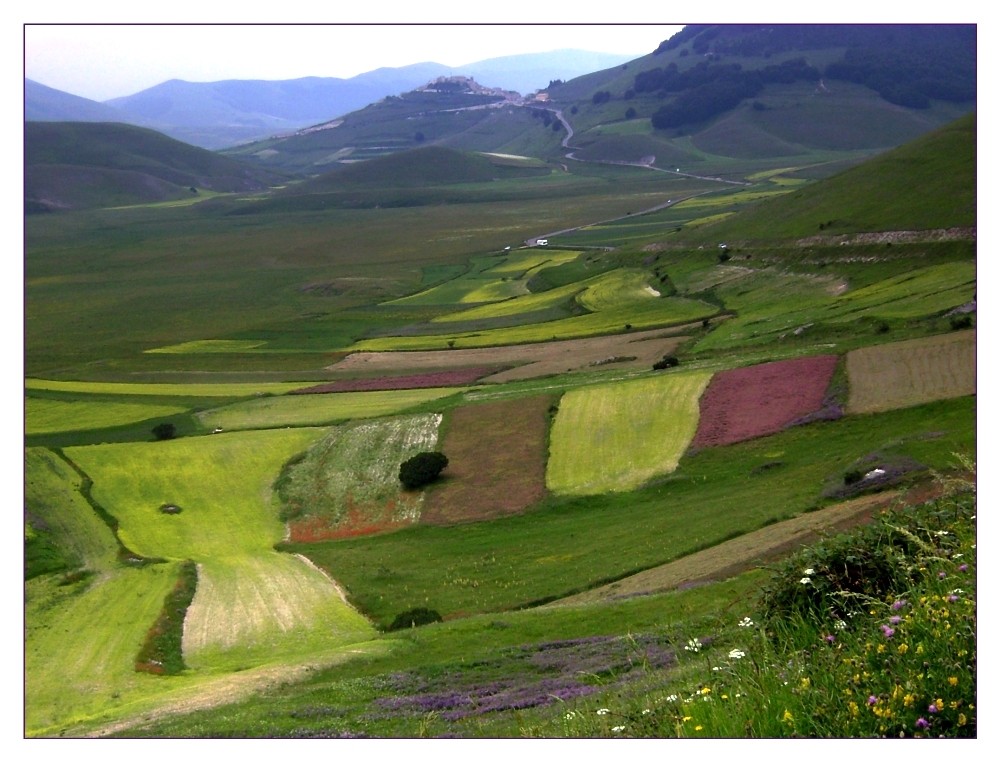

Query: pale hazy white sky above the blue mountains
<box><xmin>24</xmin><ymin>23</ymin><xmax>682</xmax><ymax>101</ymax></box>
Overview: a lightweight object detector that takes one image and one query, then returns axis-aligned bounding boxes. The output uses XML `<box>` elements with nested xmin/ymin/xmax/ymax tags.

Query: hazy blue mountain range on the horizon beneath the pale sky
<box><xmin>25</xmin><ymin>50</ymin><xmax>628</xmax><ymax>150</ymax></box>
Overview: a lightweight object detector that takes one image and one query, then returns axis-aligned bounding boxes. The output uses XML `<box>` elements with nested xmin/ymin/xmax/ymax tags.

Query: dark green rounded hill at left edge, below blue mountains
<box><xmin>24</xmin><ymin>122</ymin><xmax>284</xmax><ymax>213</ymax></box>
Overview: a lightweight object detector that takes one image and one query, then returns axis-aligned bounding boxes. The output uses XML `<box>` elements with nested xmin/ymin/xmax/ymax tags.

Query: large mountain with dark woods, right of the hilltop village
<box><xmin>547</xmin><ymin>24</ymin><xmax>977</xmax><ymax>167</ymax></box>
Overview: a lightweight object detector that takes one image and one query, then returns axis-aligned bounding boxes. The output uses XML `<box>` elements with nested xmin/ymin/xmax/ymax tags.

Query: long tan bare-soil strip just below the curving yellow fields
<box><xmin>326</xmin><ymin>326</ymin><xmax>693</xmax><ymax>383</ymax></box>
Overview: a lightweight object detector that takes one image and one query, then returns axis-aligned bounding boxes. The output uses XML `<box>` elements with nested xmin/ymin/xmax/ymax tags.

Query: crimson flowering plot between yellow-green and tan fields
<box><xmin>691</xmin><ymin>355</ymin><xmax>838</xmax><ymax>448</ymax></box>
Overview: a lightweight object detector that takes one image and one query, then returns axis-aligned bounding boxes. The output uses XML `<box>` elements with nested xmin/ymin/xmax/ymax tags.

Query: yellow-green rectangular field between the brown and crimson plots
<box><xmin>545</xmin><ymin>372</ymin><xmax>712</xmax><ymax>495</ymax></box>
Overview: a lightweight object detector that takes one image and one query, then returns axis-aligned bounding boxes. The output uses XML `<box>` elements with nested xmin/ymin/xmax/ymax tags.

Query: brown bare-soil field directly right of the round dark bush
<box><xmin>421</xmin><ymin>395</ymin><xmax>555</xmax><ymax>525</ymax></box>
